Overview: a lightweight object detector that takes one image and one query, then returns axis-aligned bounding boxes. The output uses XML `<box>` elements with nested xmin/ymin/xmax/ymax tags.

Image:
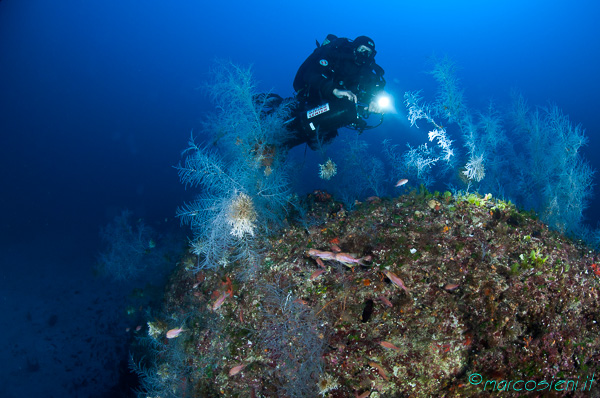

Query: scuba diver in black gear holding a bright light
<box><xmin>284</xmin><ymin>34</ymin><xmax>387</xmax><ymax>150</ymax></box>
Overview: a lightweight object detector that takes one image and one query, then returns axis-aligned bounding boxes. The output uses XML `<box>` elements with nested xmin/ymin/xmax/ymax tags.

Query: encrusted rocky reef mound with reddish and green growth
<box><xmin>134</xmin><ymin>190</ymin><xmax>600</xmax><ymax>398</ymax></box>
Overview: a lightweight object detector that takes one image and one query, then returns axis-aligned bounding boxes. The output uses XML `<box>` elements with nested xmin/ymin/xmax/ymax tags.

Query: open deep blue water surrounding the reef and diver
<box><xmin>0</xmin><ymin>0</ymin><xmax>600</xmax><ymax>397</ymax></box>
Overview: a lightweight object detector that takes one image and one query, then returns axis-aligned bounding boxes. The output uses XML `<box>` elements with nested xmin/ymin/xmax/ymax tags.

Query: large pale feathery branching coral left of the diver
<box><xmin>177</xmin><ymin>63</ymin><xmax>290</xmax><ymax>268</ymax></box>
